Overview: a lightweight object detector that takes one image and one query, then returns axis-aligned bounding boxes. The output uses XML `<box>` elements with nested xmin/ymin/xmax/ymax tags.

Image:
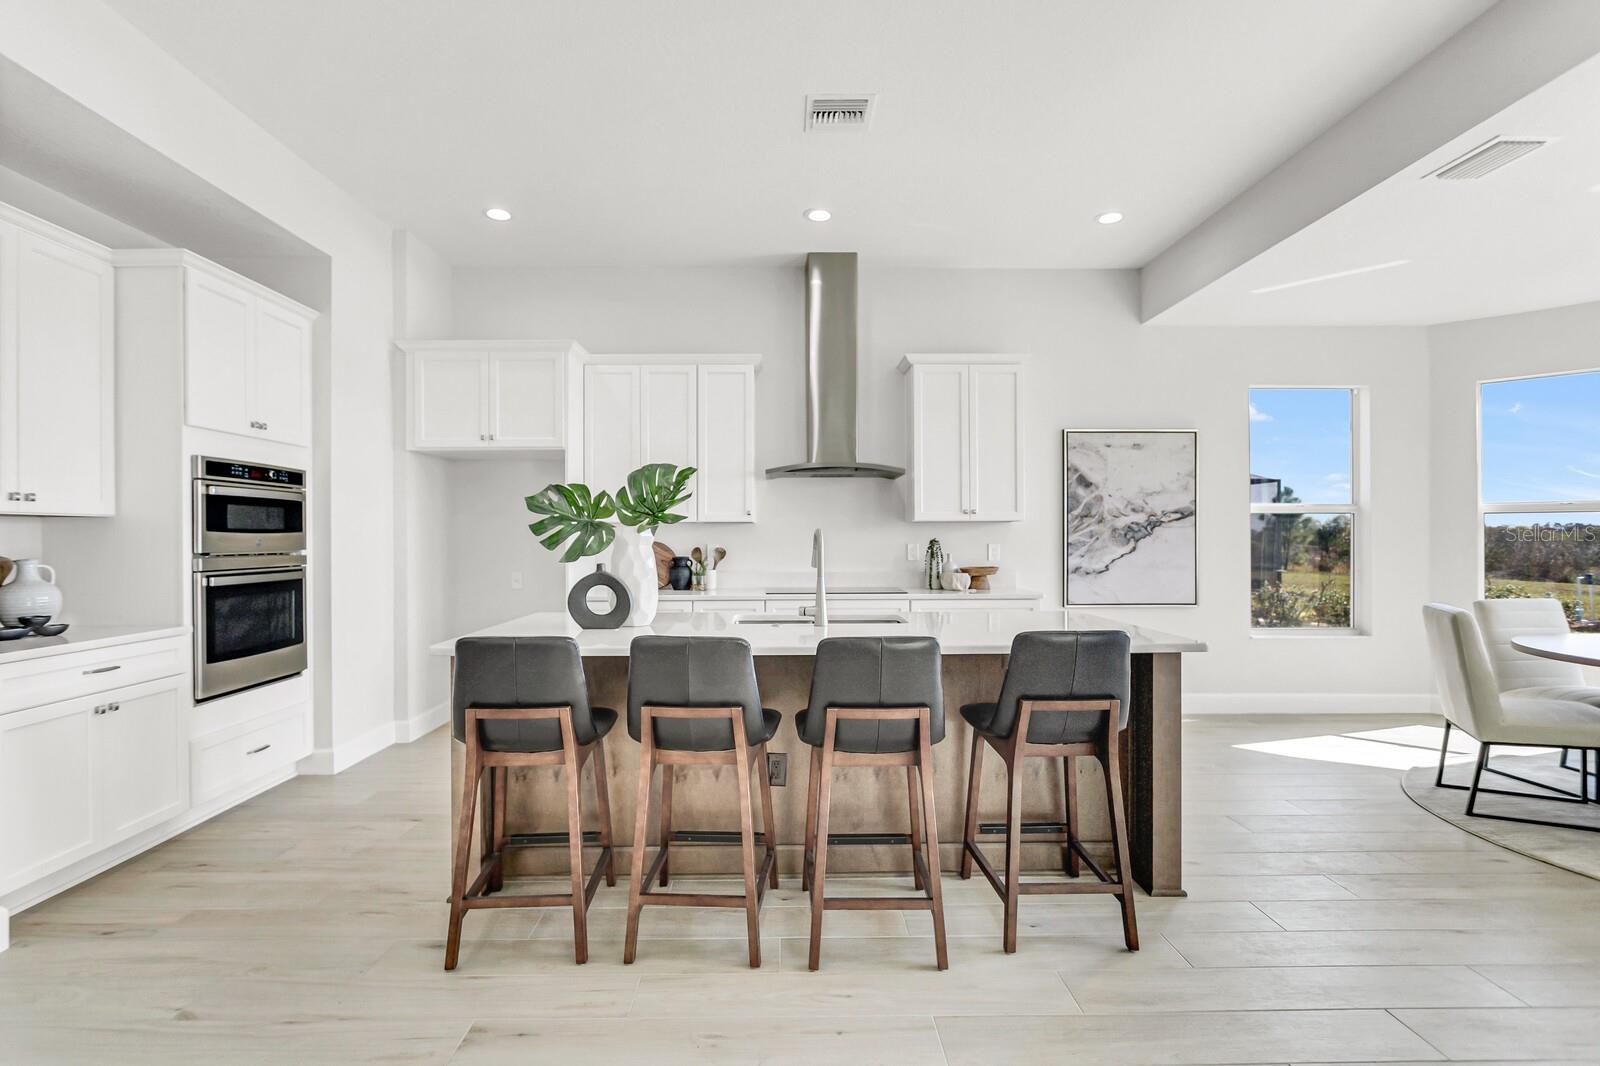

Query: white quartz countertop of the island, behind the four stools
<box><xmin>429</xmin><ymin>608</ymin><xmax>1205</xmax><ymax>655</ymax></box>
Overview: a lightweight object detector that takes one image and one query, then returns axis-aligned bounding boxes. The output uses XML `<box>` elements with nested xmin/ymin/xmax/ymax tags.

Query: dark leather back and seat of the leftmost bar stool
<box><xmin>450</xmin><ymin>637</ymin><xmax>616</xmax><ymax>752</ymax></box>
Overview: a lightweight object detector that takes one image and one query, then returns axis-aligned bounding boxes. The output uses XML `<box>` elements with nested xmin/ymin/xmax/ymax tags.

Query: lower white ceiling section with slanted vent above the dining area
<box><xmin>1160</xmin><ymin>50</ymin><xmax>1600</xmax><ymax>325</ymax></box>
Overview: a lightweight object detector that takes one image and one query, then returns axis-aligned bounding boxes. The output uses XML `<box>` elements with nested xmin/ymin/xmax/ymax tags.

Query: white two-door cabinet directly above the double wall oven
<box><xmin>183</xmin><ymin>253</ymin><xmax>317</xmax><ymax>447</ymax></box>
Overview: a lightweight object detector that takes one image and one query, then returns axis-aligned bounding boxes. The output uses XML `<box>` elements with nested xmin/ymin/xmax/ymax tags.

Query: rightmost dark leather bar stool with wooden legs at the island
<box><xmin>962</xmin><ymin>629</ymin><xmax>1139</xmax><ymax>952</ymax></box>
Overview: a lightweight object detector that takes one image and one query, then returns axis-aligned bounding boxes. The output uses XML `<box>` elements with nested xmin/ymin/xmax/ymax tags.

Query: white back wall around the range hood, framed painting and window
<box><xmin>453</xmin><ymin>261</ymin><xmax>1429</xmax><ymax>711</ymax></box>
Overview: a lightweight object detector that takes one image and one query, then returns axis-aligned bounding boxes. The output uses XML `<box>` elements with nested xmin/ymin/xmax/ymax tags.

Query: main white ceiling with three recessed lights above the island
<box><xmin>109</xmin><ymin>0</ymin><xmax>1491</xmax><ymax>267</ymax></box>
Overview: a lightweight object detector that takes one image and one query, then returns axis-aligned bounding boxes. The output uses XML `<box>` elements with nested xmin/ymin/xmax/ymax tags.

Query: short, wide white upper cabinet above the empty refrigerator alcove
<box><xmin>403</xmin><ymin>341</ymin><xmax>582</xmax><ymax>451</ymax></box>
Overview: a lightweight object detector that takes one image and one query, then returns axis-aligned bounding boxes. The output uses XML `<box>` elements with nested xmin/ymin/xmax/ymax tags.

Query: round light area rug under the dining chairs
<box><xmin>1400</xmin><ymin>744</ymin><xmax>1600</xmax><ymax>880</ymax></box>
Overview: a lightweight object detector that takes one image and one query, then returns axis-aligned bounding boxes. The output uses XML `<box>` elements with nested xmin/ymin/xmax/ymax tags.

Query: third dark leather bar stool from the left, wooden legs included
<box><xmin>795</xmin><ymin>637</ymin><xmax>950</xmax><ymax>970</ymax></box>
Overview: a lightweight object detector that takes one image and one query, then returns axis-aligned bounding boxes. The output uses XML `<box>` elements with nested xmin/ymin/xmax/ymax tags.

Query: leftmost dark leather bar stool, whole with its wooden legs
<box><xmin>445</xmin><ymin>637</ymin><xmax>616</xmax><ymax>970</ymax></box>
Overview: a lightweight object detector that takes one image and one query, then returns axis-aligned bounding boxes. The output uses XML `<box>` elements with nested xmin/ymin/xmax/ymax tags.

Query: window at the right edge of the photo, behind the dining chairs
<box><xmin>1478</xmin><ymin>371</ymin><xmax>1600</xmax><ymax>631</ymax></box>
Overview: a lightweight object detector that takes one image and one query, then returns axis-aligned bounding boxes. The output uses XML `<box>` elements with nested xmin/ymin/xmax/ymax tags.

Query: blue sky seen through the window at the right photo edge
<box><xmin>1480</xmin><ymin>371</ymin><xmax>1600</xmax><ymax>508</ymax></box>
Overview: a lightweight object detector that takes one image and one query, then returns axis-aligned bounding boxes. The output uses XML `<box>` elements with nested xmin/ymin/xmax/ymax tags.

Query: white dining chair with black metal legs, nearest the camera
<box><xmin>1422</xmin><ymin>603</ymin><xmax>1600</xmax><ymax>831</ymax></box>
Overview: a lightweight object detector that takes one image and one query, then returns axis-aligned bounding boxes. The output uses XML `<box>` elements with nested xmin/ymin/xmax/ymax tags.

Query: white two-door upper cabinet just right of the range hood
<box><xmin>901</xmin><ymin>355</ymin><xmax>1024</xmax><ymax>522</ymax></box>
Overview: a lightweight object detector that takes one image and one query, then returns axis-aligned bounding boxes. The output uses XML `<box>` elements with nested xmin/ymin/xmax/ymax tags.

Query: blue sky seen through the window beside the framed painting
<box><xmin>1250</xmin><ymin>389</ymin><xmax>1350</xmax><ymax>504</ymax></box>
